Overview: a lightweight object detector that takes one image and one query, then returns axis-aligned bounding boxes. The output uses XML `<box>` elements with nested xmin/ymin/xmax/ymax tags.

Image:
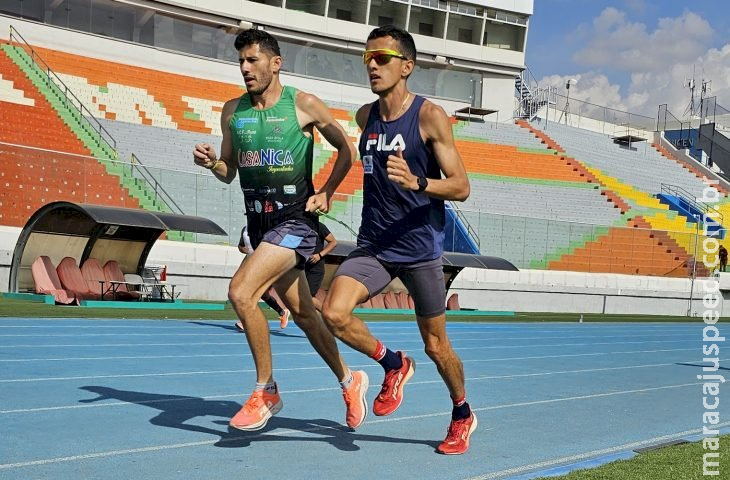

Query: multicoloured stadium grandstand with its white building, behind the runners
<box><xmin>0</xmin><ymin>0</ymin><xmax>730</xmax><ymax>314</ymax></box>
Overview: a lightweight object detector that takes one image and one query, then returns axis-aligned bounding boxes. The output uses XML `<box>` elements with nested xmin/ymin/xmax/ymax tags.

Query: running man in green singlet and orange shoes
<box><xmin>193</xmin><ymin>30</ymin><xmax>368</xmax><ymax>430</ymax></box>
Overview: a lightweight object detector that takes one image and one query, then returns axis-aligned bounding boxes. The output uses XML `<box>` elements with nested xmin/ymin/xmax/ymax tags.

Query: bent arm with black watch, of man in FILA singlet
<box><xmin>387</xmin><ymin>101</ymin><xmax>470</xmax><ymax>202</ymax></box>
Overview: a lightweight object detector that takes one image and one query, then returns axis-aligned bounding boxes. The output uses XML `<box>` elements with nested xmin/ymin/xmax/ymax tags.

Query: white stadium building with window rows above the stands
<box><xmin>0</xmin><ymin>0</ymin><xmax>533</xmax><ymax>120</ymax></box>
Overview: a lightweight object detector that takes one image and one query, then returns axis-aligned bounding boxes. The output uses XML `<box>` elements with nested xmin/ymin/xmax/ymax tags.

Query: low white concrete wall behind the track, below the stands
<box><xmin>0</xmin><ymin>227</ymin><xmax>730</xmax><ymax>316</ymax></box>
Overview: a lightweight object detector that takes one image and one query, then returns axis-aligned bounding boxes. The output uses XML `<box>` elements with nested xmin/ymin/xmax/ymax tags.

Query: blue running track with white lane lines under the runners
<box><xmin>0</xmin><ymin>318</ymin><xmax>716</xmax><ymax>480</ymax></box>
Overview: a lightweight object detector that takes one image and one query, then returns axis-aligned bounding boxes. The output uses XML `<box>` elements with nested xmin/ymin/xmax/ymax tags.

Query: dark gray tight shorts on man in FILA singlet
<box><xmin>335</xmin><ymin>248</ymin><xmax>446</xmax><ymax>318</ymax></box>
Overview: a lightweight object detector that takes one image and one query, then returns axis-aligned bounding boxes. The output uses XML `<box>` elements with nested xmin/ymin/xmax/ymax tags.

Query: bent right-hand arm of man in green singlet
<box><xmin>297</xmin><ymin>92</ymin><xmax>356</xmax><ymax>213</ymax></box>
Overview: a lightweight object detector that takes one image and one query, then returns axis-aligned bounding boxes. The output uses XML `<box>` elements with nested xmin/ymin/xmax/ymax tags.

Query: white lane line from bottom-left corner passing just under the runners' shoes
<box><xmin>0</xmin><ymin>383</ymin><xmax>701</xmax><ymax>468</ymax></box>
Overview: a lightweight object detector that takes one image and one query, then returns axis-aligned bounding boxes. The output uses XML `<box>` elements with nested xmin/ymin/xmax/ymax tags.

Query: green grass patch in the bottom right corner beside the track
<box><xmin>539</xmin><ymin>435</ymin><xmax>730</xmax><ymax>480</ymax></box>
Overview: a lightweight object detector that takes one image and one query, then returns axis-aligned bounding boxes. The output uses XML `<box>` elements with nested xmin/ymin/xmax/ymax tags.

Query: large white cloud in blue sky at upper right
<box><xmin>540</xmin><ymin>8</ymin><xmax>730</xmax><ymax>116</ymax></box>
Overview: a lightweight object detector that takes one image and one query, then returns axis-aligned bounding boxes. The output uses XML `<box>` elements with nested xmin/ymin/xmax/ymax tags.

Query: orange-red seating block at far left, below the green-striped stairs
<box><xmin>0</xmin><ymin>45</ymin><xmax>139</xmax><ymax>226</ymax></box>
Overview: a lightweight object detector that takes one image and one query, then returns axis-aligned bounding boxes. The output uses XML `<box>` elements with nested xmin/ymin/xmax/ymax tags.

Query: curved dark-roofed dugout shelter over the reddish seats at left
<box><xmin>8</xmin><ymin>202</ymin><xmax>228</xmax><ymax>292</ymax></box>
